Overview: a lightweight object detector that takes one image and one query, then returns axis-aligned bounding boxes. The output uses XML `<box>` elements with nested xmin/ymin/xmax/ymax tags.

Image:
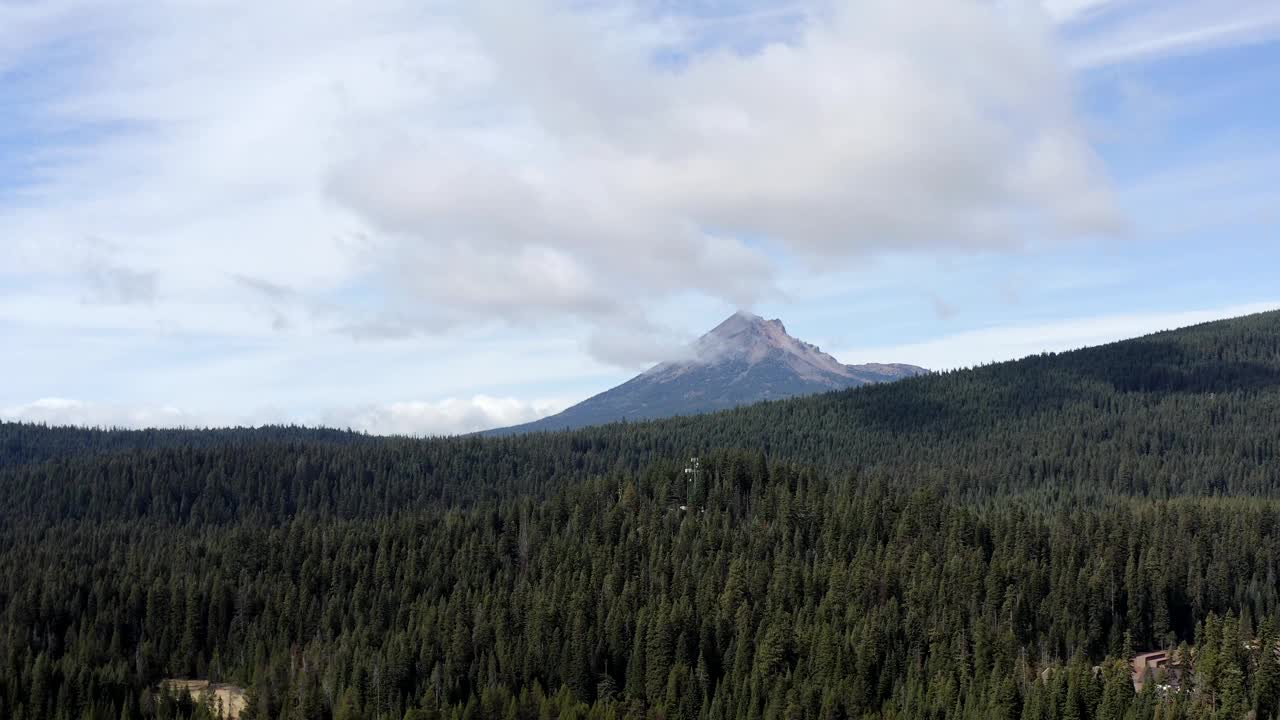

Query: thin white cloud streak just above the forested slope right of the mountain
<box><xmin>833</xmin><ymin>301</ymin><xmax>1280</xmax><ymax>370</ymax></box>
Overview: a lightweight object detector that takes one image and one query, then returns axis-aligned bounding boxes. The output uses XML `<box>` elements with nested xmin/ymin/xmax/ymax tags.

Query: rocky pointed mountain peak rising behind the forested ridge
<box><xmin>493</xmin><ymin>313</ymin><xmax>928</xmax><ymax>434</ymax></box>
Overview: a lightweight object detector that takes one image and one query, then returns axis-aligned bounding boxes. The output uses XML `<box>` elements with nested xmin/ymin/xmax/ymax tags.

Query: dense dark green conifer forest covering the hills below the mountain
<box><xmin>0</xmin><ymin>313</ymin><xmax>1280</xmax><ymax>720</ymax></box>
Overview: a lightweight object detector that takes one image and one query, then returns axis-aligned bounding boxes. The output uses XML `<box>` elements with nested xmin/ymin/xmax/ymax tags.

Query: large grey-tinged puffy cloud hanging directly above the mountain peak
<box><xmin>328</xmin><ymin>0</ymin><xmax>1123</xmax><ymax>327</ymax></box>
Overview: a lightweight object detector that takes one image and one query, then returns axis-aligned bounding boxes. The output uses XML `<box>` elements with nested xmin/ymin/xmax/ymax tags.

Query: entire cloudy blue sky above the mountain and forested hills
<box><xmin>0</xmin><ymin>0</ymin><xmax>1280</xmax><ymax>434</ymax></box>
